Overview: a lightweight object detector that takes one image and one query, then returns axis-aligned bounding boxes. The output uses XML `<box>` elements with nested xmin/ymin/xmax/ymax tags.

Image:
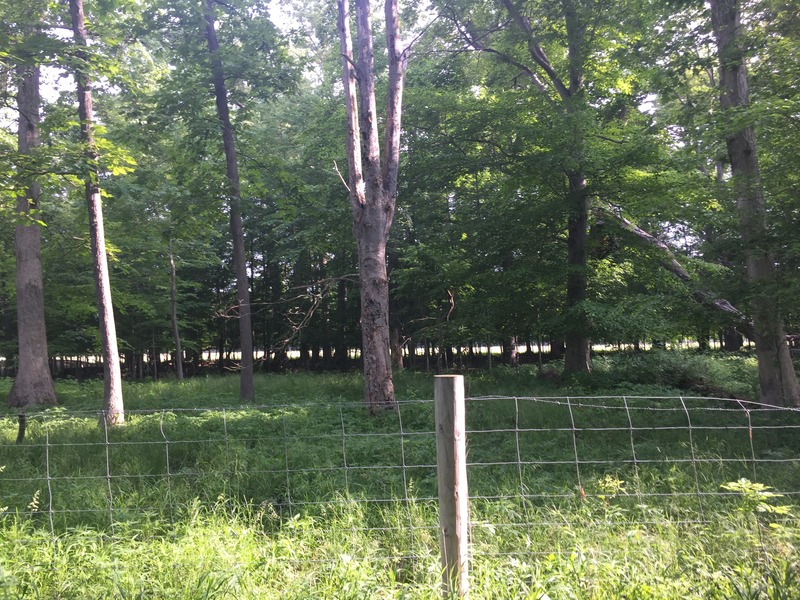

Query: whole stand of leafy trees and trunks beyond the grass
<box><xmin>0</xmin><ymin>0</ymin><xmax>800</xmax><ymax>412</ymax></box>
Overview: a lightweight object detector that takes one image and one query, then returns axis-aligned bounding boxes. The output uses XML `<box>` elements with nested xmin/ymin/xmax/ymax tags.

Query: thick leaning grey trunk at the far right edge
<box><xmin>710</xmin><ymin>0</ymin><xmax>800</xmax><ymax>406</ymax></box>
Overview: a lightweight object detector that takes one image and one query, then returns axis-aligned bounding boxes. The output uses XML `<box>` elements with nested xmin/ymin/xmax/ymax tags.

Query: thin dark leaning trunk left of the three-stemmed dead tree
<box><xmin>205</xmin><ymin>0</ymin><xmax>255</xmax><ymax>402</ymax></box>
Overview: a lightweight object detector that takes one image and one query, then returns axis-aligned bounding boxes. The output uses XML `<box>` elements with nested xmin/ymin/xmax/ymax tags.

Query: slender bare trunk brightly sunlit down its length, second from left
<box><xmin>69</xmin><ymin>0</ymin><xmax>125</xmax><ymax>425</ymax></box>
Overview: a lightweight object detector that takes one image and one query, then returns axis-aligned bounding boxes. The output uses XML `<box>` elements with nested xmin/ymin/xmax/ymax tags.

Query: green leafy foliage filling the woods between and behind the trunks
<box><xmin>0</xmin><ymin>0</ymin><xmax>800</xmax><ymax>404</ymax></box>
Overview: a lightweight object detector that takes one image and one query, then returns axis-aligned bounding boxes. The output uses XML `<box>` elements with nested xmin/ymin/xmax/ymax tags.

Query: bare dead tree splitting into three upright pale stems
<box><xmin>337</xmin><ymin>0</ymin><xmax>408</xmax><ymax>412</ymax></box>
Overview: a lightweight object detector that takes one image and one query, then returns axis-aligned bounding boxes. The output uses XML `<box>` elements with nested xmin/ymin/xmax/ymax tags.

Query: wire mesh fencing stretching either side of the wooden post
<box><xmin>0</xmin><ymin>396</ymin><xmax>800</xmax><ymax>576</ymax></box>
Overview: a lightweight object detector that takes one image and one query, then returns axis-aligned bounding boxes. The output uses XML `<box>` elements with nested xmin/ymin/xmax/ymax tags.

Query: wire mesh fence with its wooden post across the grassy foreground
<box><xmin>0</xmin><ymin>380</ymin><xmax>800</xmax><ymax>598</ymax></box>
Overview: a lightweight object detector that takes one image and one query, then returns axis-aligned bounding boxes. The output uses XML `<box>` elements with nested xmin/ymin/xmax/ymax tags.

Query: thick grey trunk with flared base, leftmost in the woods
<box><xmin>8</xmin><ymin>59</ymin><xmax>57</xmax><ymax>408</ymax></box>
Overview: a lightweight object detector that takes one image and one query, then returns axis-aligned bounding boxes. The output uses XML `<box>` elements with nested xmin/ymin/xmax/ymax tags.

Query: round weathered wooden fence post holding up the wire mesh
<box><xmin>434</xmin><ymin>375</ymin><xmax>469</xmax><ymax>598</ymax></box>
